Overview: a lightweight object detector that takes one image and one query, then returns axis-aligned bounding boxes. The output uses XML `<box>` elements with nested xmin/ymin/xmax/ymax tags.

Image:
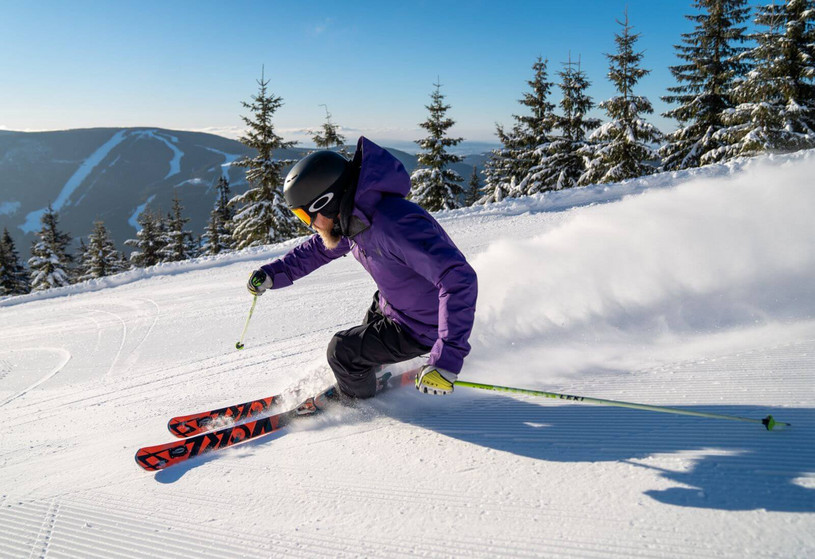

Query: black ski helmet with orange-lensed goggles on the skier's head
<box><xmin>283</xmin><ymin>150</ymin><xmax>351</xmax><ymax>225</ymax></box>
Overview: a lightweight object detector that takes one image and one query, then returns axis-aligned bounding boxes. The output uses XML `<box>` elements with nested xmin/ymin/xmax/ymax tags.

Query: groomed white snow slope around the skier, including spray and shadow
<box><xmin>0</xmin><ymin>152</ymin><xmax>815</xmax><ymax>558</ymax></box>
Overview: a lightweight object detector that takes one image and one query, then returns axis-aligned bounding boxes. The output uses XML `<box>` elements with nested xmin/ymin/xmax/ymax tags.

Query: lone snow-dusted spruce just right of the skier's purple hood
<box><xmin>410</xmin><ymin>82</ymin><xmax>464</xmax><ymax>212</ymax></box>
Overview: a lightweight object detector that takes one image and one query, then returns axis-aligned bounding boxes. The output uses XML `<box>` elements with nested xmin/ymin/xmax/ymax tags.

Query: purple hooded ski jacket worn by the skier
<box><xmin>262</xmin><ymin>137</ymin><xmax>478</xmax><ymax>373</ymax></box>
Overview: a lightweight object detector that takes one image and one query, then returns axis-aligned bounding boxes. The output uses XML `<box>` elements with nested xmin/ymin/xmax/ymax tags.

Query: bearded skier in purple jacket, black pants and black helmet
<box><xmin>247</xmin><ymin>137</ymin><xmax>478</xmax><ymax>398</ymax></box>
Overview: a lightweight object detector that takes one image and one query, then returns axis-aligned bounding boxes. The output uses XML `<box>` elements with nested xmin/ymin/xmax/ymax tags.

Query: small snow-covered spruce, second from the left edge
<box><xmin>28</xmin><ymin>204</ymin><xmax>74</xmax><ymax>291</ymax></box>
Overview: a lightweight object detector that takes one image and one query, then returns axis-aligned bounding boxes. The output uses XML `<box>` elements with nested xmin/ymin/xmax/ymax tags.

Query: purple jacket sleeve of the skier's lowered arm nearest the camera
<box><xmin>383</xmin><ymin>213</ymin><xmax>478</xmax><ymax>373</ymax></box>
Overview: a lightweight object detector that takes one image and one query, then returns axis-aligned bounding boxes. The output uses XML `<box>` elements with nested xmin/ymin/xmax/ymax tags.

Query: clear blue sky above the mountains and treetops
<box><xmin>0</xmin><ymin>0</ymin><xmax>764</xmax><ymax>150</ymax></box>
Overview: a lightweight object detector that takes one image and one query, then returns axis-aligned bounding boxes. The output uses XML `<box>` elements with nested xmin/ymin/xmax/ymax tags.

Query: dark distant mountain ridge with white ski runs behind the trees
<box><xmin>0</xmin><ymin>128</ymin><xmax>483</xmax><ymax>258</ymax></box>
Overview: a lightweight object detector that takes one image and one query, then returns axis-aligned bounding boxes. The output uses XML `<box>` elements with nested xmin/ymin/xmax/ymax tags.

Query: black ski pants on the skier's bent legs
<box><xmin>328</xmin><ymin>291</ymin><xmax>431</xmax><ymax>398</ymax></box>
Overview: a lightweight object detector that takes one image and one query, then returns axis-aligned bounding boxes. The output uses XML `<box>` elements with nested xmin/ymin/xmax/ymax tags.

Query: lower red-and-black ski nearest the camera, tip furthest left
<box><xmin>136</xmin><ymin>370</ymin><xmax>417</xmax><ymax>472</ymax></box>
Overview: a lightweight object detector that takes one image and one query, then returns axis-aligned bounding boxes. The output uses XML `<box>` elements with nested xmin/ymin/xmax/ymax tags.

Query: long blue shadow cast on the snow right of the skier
<box><xmin>391</xmin><ymin>395</ymin><xmax>815</xmax><ymax>512</ymax></box>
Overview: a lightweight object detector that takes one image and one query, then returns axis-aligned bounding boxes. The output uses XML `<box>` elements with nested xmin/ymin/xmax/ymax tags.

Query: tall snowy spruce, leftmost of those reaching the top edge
<box><xmin>659</xmin><ymin>0</ymin><xmax>749</xmax><ymax>171</ymax></box>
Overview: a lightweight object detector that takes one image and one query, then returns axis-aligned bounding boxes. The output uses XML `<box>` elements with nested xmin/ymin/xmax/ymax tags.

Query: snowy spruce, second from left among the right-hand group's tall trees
<box><xmin>520</xmin><ymin>58</ymin><xmax>600</xmax><ymax>194</ymax></box>
